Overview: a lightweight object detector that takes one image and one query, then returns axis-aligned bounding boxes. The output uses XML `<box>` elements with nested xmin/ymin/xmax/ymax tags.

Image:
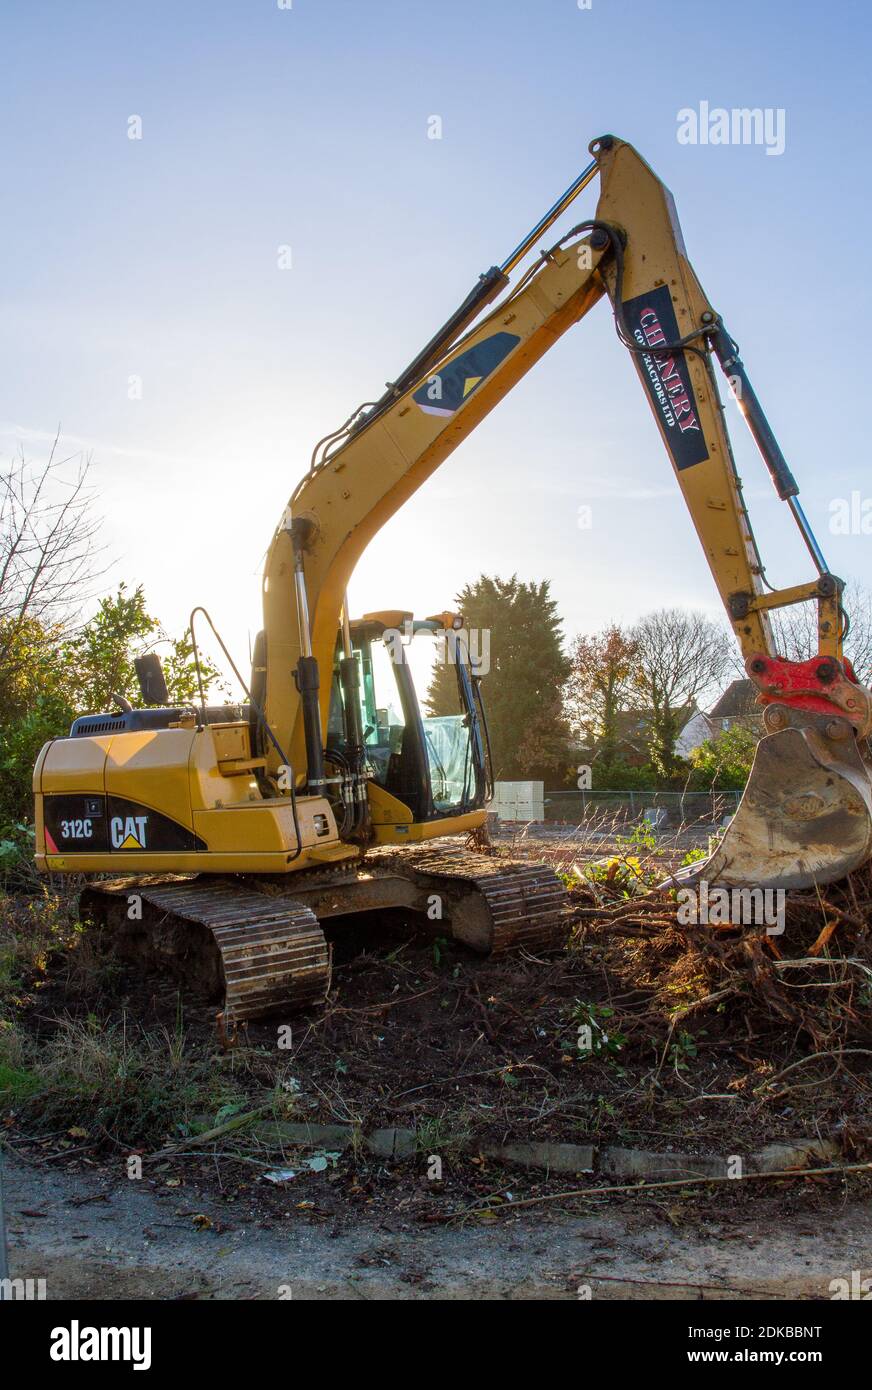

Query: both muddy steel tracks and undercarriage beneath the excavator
<box><xmin>81</xmin><ymin>841</ymin><xmax>572</xmax><ymax>1030</ymax></box>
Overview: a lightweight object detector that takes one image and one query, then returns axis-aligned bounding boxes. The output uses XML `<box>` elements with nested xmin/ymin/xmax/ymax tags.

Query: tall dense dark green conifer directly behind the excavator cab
<box><xmin>426</xmin><ymin>574</ymin><xmax>569</xmax><ymax>781</ymax></box>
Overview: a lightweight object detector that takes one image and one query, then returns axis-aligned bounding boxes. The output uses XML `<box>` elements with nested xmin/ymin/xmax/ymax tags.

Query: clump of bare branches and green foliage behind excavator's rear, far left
<box><xmin>0</xmin><ymin>450</ymin><xmax>225</xmax><ymax>872</ymax></box>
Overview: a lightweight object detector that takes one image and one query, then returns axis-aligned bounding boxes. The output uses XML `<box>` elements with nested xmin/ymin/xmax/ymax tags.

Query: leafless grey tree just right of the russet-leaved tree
<box><xmin>630</xmin><ymin>609</ymin><xmax>730</xmax><ymax>776</ymax></box>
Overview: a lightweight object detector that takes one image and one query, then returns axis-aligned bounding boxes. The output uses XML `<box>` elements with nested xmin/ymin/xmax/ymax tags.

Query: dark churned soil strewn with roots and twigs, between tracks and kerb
<box><xmin>13</xmin><ymin>909</ymin><xmax>872</xmax><ymax>1173</ymax></box>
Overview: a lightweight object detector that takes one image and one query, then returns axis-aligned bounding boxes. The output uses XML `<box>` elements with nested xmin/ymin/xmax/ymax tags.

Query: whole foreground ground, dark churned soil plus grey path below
<box><xmin>1</xmin><ymin>817</ymin><xmax>872</xmax><ymax>1298</ymax></box>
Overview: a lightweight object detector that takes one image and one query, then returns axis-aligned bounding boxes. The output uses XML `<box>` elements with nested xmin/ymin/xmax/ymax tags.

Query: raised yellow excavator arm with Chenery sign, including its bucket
<box><xmin>264</xmin><ymin>136</ymin><xmax>872</xmax><ymax>885</ymax></box>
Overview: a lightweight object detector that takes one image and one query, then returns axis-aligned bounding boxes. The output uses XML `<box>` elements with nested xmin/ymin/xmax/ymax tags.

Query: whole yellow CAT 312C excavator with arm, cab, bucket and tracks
<box><xmin>33</xmin><ymin>136</ymin><xmax>872</xmax><ymax>1026</ymax></box>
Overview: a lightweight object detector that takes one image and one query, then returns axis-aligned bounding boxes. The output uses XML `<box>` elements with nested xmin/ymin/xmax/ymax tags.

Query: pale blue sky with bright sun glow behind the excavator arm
<box><xmin>0</xmin><ymin>0</ymin><xmax>872</xmax><ymax>675</ymax></box>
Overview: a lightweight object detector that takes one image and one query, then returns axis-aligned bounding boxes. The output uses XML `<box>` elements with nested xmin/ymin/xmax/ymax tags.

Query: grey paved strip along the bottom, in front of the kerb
<box><xmin>6</xmin><ymin>1159</ymin><xmax>872</xmax><ymax>1301</ymax></box>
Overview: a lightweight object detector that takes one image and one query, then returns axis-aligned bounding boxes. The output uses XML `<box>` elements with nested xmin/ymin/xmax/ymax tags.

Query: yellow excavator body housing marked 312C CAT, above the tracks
<box><xmin>33</xmin><ymin>721</ymin><xmax>485</xmax><ymax>874</ymax></box>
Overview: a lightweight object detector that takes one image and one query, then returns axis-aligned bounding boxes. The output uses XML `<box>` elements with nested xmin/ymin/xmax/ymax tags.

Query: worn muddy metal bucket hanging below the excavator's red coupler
<box><xmin>680</xmin><ymin>714</ymin><xmax>872</xmax><ymax>888</ymax></box>
